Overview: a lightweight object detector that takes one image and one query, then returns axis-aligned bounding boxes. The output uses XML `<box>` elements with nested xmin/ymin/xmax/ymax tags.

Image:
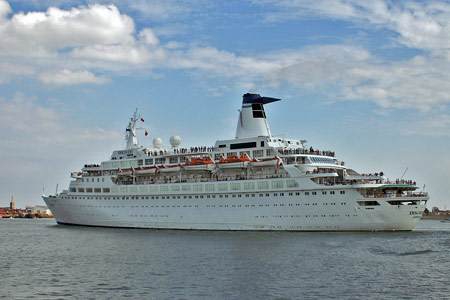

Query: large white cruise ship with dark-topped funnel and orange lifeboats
<box><xmin>42</xmin><ymin>93</ymin><xmax>429</xmax><ymax>231</ymax></box>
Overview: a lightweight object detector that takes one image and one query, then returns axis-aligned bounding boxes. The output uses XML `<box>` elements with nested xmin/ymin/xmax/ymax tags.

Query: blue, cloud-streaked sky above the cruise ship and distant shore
<box><xmin>0</xmin><ymin>0</ymin><xmax>450</xmax><ymax>209</ymax></box>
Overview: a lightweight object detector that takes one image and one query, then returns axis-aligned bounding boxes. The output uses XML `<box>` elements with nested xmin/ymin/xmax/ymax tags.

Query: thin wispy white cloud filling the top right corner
<box><xmin>254</xmin><ymin>0</ymin><xmax>450</xmax><ymax>52</ymax></box>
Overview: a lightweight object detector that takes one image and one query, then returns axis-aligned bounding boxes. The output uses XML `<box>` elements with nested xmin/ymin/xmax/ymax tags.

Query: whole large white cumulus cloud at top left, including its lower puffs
<box><xmin>0</xmin><ymin>0</ymin><xmax>165</xmax><ymax>85</ymax></box>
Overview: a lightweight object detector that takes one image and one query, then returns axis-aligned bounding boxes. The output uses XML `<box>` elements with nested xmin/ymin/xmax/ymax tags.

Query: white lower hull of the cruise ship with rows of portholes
<box><xmin>44</xmin><ymin>181</ymin><xmax>426</xmax><ymax>231</ymax></box>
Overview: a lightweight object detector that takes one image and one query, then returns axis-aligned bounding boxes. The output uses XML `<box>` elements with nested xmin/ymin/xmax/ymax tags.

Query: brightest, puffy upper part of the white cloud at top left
<box><xmin>0</xmin><ymin>5</ymin><xmax>134</xmax><ymax>56</ymax></box>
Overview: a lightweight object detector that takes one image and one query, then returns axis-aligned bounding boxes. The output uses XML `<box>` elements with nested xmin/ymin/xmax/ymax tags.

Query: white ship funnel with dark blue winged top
<box><xmin>236</xmin><ymin>93</ymin><xmax>281</xmax><ymax>139</ymax></box>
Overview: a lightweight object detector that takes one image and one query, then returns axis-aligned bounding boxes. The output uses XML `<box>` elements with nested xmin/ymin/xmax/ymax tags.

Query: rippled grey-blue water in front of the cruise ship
<box><xmin>0</xmin><ymin>219</ymin><xmax>450</xmax><ymax>299</ymax></box>
